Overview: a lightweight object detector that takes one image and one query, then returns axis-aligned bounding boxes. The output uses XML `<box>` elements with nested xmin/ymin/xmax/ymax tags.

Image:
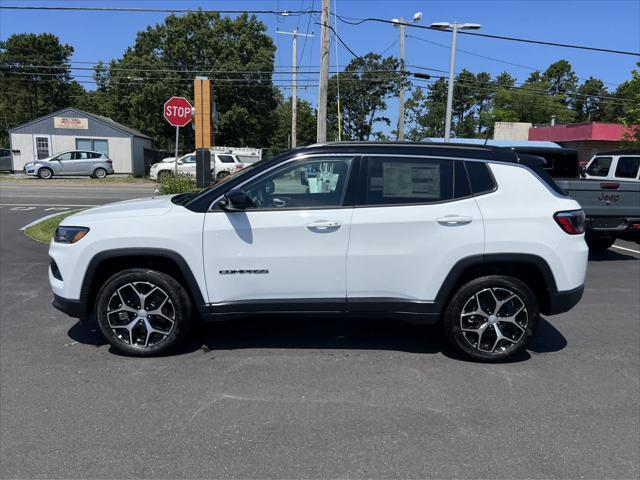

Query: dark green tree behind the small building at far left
<box><xmin>0</xmin><ymin>33</ymin><xmax>76</xmax><ymax>144</ymax></box>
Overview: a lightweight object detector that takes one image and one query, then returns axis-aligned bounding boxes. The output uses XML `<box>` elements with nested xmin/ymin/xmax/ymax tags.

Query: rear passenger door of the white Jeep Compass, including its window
<box><xmin>347</xmin><ymin>156</ymin><xmax>484</xmax><ymax>311</ymax></box>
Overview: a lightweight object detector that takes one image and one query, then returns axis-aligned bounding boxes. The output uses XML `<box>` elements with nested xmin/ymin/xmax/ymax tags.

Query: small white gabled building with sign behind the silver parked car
<box><xmin>9</xmin><ymin>107</ymin><xmax>155</xmax><ymax>176</ymax></box>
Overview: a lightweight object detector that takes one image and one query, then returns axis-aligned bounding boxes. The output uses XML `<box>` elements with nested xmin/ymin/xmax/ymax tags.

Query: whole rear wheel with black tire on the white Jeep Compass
<box><xmin>443</xmin><ymin>275</ymin><xmax>540</xmax><ymax>362</ymax></box>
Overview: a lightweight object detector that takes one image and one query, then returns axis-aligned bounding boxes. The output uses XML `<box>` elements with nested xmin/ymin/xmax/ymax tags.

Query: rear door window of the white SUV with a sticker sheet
<box><xmin>364</xmin><ymin>157</ymin><xmax>470</xmax><ymax>205</ymax></box>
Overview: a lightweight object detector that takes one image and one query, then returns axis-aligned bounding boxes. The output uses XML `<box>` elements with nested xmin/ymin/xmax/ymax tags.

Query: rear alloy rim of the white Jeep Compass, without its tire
<box><xmin>460</xmin><ymin>287</ymin><xmax>529</xmax><ymax>354</ymax></box>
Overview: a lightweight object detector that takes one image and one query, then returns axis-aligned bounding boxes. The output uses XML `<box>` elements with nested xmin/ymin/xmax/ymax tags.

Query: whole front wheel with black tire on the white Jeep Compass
<box><xmin>96</xmin><ymin>268</ymin><xmax>192</xmax><ymax>357</ymax></box>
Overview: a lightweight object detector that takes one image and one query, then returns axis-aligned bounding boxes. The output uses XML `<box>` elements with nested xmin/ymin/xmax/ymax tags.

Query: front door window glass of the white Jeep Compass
<box><xmin>243</xmin><ymin>158</ymin><xmax>352</xmax><ymax>210</ymax></box>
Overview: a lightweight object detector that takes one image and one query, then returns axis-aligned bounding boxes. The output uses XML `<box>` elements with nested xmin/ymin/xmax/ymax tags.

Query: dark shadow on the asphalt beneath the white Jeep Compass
<box><xmin>68</xmin><ymin>316</ymin><xmax>567</xmax><ymax>363</ymax></box>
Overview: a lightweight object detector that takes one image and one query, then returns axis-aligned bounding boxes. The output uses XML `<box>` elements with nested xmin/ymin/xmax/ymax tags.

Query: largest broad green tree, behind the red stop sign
<box><xmin>96</xmin><ymin>12</ymin><xmax>277</xmax><ymax>149</ymax></box>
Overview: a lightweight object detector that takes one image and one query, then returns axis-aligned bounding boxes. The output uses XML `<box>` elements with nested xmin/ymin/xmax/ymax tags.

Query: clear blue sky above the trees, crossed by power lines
<box><xmin>0</xmin><ymin>0</ymin><xmax>640</xmax><ymax>129</ymax></box>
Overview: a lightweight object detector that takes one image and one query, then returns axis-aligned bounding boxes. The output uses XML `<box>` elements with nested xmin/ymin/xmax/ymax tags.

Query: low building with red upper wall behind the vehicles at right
<box><xmin>529</xmin><ymin>122</ymin><xmax>640</xmax><ymax>163</ymax></box>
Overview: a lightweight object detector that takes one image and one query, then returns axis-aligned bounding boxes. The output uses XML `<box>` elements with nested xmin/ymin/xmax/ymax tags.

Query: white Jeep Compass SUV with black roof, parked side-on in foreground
<box><xmin>49</xmin><ymin>143</ymin><xmax>587</xmax><ymax>361</ymax></box>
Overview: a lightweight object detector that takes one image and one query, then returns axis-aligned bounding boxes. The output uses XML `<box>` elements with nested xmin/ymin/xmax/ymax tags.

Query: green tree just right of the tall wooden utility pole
<box><xmin>327</xmin><ymin>53</ymin><xmax>399</xmax><ymax>140</ymax></box>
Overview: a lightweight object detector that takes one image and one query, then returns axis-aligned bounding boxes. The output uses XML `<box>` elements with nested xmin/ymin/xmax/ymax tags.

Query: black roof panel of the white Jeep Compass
<box><xmin>294</xmin><ymin>142</ymin><xmax>518</xmax><ymax>163</ymax></box>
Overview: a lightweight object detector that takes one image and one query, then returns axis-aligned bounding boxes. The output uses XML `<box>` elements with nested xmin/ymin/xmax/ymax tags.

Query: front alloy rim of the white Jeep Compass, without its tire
<box><xmin>107</xmin><ymin>282</ymin><xmax>176</xmax><ymax>348</ymax></box>
